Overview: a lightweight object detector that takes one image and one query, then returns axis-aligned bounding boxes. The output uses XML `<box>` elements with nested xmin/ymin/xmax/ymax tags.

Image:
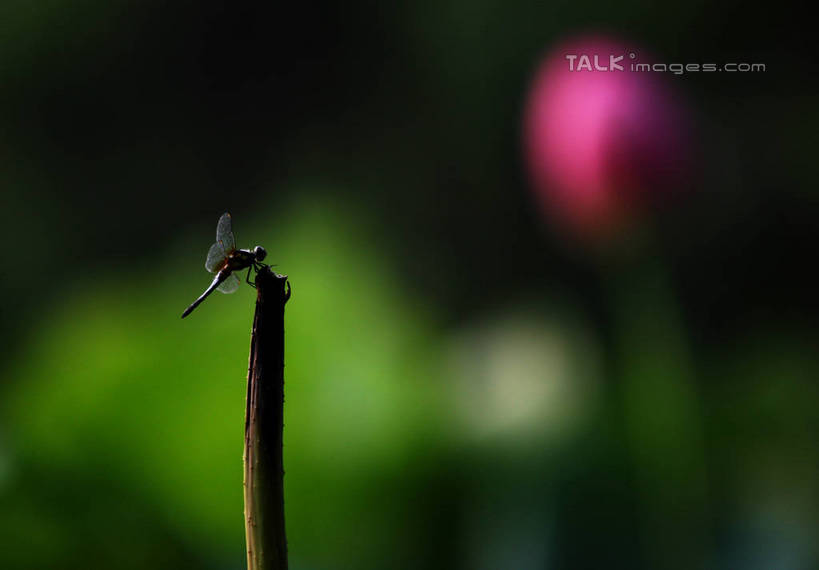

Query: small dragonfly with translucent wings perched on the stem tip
<box><xmin>182</xmin><ymin>212</ymin><xmax>267</xmax><ymax>319</ymax></box>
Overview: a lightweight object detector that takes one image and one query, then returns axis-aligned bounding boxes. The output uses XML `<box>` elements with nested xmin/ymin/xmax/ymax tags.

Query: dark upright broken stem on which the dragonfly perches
<box><xmin>244</xmin><ymin>267</ymin><xmax>290</xmax><ymax>570</ymax></box>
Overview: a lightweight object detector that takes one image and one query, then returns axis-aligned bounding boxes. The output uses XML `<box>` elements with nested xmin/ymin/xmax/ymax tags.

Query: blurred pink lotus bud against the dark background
<box><xmin>524</xmin><ymin>36</ymin><xmax>689</xmax><ymax>237</ymax></box>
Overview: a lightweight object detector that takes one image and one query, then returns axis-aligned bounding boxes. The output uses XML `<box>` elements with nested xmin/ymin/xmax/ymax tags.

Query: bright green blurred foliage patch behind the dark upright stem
<box><xmin>2</xmin><ymin>199</ymin><xmax>454</xmax><ymax>567</ymax></box>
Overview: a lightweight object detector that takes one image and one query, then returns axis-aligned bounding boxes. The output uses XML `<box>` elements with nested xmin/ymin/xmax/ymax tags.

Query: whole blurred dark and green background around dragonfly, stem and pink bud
<box><xmin>0</xmin><ymin>0</ymin><xmax>819</xmax><ymax>569</ymax></box>
